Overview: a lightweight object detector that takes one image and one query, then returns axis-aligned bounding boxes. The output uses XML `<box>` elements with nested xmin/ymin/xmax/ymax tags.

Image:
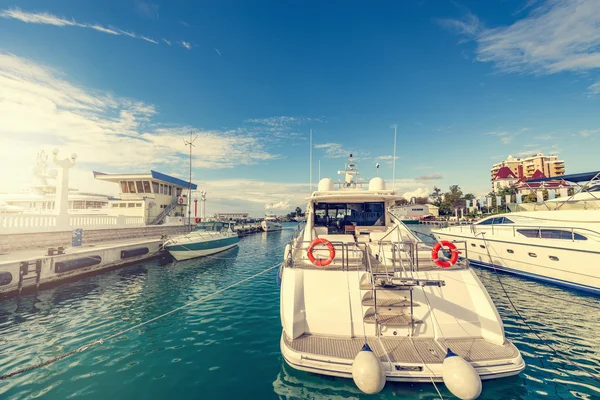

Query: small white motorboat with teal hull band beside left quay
<box><xmin>163</xmin><ymin>221</ymin><xmax>240</xmax><ymax>261</ymax></box>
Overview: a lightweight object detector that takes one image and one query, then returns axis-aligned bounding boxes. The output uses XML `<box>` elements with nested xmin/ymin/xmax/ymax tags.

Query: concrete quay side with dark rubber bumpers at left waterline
<box><xmin>0</xmin><ymin>238</ymin><xmax>164</xmax><ymax>297</ymax></box>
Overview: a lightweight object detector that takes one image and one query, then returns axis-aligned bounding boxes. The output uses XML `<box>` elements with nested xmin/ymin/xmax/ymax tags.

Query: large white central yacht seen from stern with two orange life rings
<box><xmin>279</xmin><ymin>159</ymin><xmax>525</xmax><ymax>393</ymax></box>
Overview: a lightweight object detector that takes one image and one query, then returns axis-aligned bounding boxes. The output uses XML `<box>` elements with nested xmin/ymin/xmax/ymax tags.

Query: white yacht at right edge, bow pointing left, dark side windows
<box><xmin>433</xmin><ymin>171</ymin><xmax>600</xmax><ymax>294</ymax></box>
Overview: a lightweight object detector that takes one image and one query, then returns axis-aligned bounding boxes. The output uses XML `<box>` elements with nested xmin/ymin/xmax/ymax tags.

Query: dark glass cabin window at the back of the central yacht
<box><xmin>315</xmin><ymin>202</ymin><xmax>385</xmax><ymax>233</ymax></box>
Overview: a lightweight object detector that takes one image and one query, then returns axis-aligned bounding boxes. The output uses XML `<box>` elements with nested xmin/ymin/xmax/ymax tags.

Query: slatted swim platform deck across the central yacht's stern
<box><xmin>283</xmin><ymin>333</ymin><xmax>519</xmax><ymax>364</ymax></box>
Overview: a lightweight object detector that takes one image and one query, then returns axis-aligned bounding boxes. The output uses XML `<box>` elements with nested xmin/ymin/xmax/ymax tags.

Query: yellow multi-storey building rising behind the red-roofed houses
<box><xmin>490</xmin><ymin>153</ymin><xmax>565</xmax><ymax>188</ymax></box>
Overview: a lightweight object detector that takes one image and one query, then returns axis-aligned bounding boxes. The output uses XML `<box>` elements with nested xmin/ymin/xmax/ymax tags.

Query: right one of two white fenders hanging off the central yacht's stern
<box><xmin>442</xmin><ymin>349</ymin><xmax>481</xmax><ymax>400</ymax></box>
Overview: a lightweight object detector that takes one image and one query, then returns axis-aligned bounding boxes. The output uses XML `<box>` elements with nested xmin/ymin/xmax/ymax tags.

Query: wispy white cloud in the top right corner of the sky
<box><xmin>442</xmin><ymin>0</ymin><xmax>600</xmax><ymax>79</ymax></box>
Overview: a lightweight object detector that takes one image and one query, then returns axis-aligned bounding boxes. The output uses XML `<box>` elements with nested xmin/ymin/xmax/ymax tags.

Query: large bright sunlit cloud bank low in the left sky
<box><xmin>0</xmin><ymin>53</ymin><xmax>278</xmax><ymax>194</ymax></box>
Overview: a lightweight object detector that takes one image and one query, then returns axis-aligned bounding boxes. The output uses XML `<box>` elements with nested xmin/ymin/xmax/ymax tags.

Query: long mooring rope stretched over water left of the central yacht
<box><xmin>0</xmin><ymin>263</ymin><xmax>281</xmax><ymax>380</ymax></box>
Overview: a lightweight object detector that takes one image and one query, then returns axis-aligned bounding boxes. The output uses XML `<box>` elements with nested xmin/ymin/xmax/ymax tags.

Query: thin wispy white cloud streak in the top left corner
<box><xmin>0</xmin><ymin>8</ymin><xmax>169</xmax><ymax>44</ymax></box>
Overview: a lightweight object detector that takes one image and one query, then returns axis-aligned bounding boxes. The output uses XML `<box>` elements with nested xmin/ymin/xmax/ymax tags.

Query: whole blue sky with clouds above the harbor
<box><xmin>0</xmin><ymin>0</ymin><xmax>600</xmax><ymax>215</ymax></box>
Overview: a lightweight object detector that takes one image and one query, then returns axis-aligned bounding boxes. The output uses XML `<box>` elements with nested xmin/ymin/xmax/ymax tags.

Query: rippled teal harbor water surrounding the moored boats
<box><xmin>0</xmin><ymin>225</ymin><xmax>600</xmax><ymax>399</ymax></box>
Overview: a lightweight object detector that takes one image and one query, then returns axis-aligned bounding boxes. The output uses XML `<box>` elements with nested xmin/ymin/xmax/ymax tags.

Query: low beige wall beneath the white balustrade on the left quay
<box><xmin>0</xmin><ymin>225</ymin><xmax>189</xmax><ymax>254</ymax></box>
